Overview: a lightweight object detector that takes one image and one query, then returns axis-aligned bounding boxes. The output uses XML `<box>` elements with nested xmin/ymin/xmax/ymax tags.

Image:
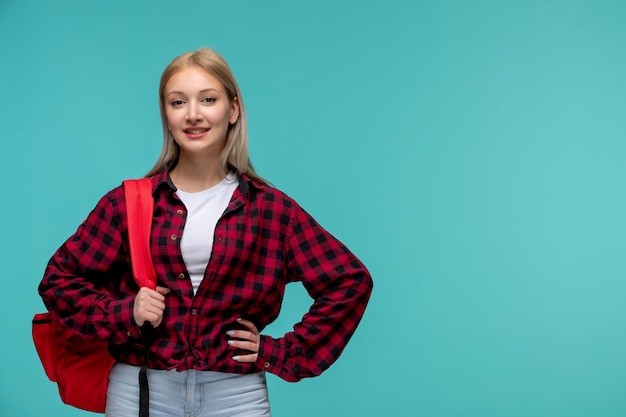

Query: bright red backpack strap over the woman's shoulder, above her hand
<box><xmin>124</xmin><ymin>178</ymin><xmax>156</xmax><ymax>290</ymax></box>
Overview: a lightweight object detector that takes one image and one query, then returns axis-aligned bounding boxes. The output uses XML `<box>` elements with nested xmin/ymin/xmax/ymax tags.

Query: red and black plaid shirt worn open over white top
<box><xmin>39</xmin><ymin>171</ymin><xmax>372</xmax><ymax>381</ymax></box>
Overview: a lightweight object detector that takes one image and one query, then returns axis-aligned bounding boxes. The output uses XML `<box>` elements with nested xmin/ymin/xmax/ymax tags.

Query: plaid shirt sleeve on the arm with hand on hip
<box><xmin>257</xmin><ymin>205</ymin><xmax>373</xmax><ymax>382</ymax></box>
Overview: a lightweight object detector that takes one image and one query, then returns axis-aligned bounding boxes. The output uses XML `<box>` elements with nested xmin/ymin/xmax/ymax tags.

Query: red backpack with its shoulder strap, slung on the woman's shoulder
<box><xmin>33</xmin><ymin>178</ymin><xmax>156</xmax><ymax>415</ymax></box>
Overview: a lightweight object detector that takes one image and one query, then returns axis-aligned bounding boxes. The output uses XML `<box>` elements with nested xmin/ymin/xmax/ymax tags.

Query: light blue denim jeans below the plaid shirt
<box><xmin>105</xmin><ymin>363</ymin><xmax>271</xmax><ymax>417</ymax></box>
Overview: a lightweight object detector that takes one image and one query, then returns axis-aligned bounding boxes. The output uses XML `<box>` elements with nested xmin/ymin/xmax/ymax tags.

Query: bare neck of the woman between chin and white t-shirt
<box><xmin>170</xmin><ymin>153</ymin><xmax>228</xmax><ymax>193</ymax></box>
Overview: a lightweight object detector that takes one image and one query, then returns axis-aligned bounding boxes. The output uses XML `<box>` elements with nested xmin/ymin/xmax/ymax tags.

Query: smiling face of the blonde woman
<box><xmin>163</xmin><ymin>65</ymin><xmax>239</xmax><ymax>158</ymax></box>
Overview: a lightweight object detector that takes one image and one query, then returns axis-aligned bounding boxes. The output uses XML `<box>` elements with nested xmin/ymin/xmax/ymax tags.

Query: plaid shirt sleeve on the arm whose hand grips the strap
<box><xmin>39</xmin><ymin>192</ymin><xmax>139</xmax><ymax>343</ymax></box>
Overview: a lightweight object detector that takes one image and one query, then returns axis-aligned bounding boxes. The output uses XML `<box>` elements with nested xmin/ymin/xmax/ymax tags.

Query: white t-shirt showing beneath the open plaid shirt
<box><xmin>176</xmin><ymin>172</ymin><xmax>239</xmax><ymax>294</ymax></box>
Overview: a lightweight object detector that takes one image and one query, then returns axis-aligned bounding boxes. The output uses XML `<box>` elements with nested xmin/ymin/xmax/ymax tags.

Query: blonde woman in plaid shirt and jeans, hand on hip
<box><xmin>39</xmin><ymin>49</ymin><xmax>372</xmax><ymax>417</ymax></box>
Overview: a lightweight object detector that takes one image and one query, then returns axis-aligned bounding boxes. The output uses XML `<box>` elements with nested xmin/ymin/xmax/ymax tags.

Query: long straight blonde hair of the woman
<box><xmin>146</xmin><ymin>48</ymin><xmax>265</xmax><ymax>182</ymax></box>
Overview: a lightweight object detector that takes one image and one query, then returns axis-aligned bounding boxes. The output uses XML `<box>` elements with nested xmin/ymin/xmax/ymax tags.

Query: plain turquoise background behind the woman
<box><xmin>0</xmin><ymin>0</ymin><xmax>626</xmax><ymax>417</ymax></box>
